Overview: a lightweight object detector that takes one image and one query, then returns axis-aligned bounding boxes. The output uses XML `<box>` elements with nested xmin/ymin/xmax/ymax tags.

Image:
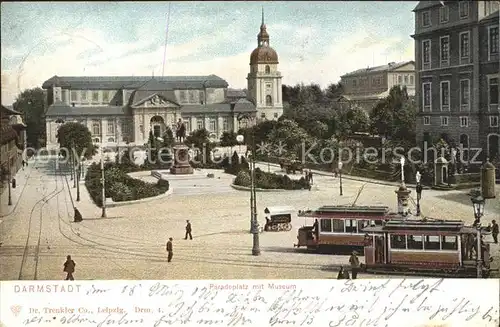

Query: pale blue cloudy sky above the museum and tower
<box><xmin>1</xmin><ymin>1</ymin><xmax>418</xmax><ymax>105</ymax></box>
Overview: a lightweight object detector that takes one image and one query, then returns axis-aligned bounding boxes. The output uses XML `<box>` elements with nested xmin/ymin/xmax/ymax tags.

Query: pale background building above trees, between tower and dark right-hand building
<box><xmin>340</xmin><ymin>61</ymin><xmax>415</xmax><ymax>113</ymax></box>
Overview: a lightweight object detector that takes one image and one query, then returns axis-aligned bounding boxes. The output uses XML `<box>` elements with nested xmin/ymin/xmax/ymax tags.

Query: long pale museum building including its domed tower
<box><xmin>42</xmin><ymin>11</ymin><xmax>283</xmax><ymax>148</ymax></box>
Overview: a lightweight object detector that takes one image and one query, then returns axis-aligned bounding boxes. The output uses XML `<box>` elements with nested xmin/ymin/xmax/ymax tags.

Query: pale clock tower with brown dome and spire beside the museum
<box><xmin>247</xmin><ymin>9</ymin><xmax>283</xmax><ymax>120</ymax></box>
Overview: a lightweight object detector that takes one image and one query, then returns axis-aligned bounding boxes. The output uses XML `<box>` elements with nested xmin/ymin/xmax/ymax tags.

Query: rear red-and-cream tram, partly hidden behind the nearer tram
<box><xmin>294</xmin><ymin>206</ymin><xmax>390</xmax><ymax>254</ymax></box>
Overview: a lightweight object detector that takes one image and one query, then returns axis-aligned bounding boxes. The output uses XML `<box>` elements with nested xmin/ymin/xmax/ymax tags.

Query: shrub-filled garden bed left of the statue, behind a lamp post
<box><xmin>85</xmin><ymin>163</ymin><xmax>169</xmax><ymax>207</ymax></box>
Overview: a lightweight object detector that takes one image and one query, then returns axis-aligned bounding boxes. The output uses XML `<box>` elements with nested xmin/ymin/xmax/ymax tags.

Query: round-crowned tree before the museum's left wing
<box><xmin>56</xmin><ymin>122</ymin><xmax>97</xmax><ymax>159</ymax></box>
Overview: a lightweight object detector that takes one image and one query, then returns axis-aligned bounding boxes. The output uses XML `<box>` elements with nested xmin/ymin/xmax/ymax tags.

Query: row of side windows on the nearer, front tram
<box><xmin>390</xmin><ymin>235</ymin><xmax>458</xmax><ymax>251</ymax></box>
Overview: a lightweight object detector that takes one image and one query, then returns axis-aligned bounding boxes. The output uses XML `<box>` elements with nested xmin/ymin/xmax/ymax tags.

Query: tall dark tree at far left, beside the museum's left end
<box><xmin>13</xmin><ymin>87</ymin><xmax>48</xmax><ymax>148</ymax></box>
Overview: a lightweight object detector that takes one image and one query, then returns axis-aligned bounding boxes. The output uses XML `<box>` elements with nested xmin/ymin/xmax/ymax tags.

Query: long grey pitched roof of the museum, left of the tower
<box><xmin>42</xmin><ymin>75</ymin><xmax>228</xmax><ymax>91</ymax></box>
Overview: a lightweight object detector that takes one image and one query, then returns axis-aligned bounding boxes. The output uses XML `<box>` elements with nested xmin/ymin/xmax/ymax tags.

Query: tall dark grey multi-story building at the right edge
<box><xmin>412</xmin><ymin>1</ymin><xmax>500</xmax><ymax>159</ymax></box>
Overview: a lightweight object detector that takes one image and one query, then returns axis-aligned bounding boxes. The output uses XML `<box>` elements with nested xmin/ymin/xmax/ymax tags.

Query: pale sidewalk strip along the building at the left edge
<box><xmin>0</xmin><ymin>159</ymin><xmax>36</xmax><ymax>218</ymax></box>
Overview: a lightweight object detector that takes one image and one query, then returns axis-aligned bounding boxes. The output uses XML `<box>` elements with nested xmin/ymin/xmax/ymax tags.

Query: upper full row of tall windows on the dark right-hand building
<box><xmin>422</xmin><ymin>26</ymin><xmax>499</xmax><ymax>70</ymax></box>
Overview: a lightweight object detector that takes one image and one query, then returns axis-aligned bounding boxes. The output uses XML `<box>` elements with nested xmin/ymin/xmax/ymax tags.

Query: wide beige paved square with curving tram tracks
<box><xmin>0</xmin><ymin>158</ymin><xmax>500</xmax><ymax>280</ymax></box>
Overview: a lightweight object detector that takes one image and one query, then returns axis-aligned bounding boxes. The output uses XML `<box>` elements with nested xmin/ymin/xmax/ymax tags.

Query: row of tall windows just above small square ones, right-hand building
<box><xmin>422</xmin><ymin>77</ymin><xmax>499</xmax><ymax>111</ymax></box>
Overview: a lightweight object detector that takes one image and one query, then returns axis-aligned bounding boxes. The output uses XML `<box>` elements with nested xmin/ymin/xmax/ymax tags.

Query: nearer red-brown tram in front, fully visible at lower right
<box><xmin>363</xmin><ymin>219</ymin><xmax>493</xmax><ymax>277</ymax></box>
